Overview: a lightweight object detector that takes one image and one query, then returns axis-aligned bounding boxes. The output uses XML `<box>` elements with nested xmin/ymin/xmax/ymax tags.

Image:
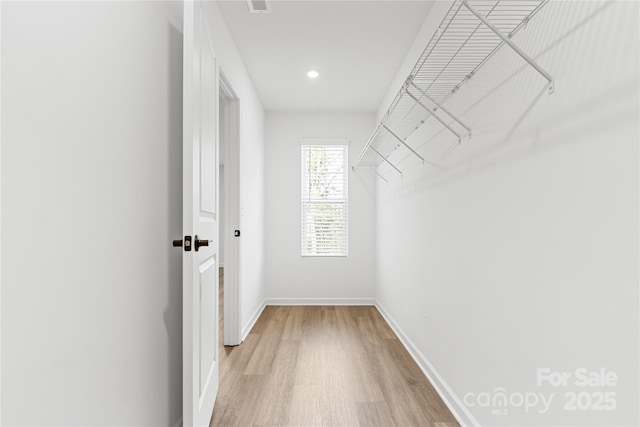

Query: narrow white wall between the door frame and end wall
<box><xmin>203</xmin><ymin>2</ymin><xmax>266</xmax><ymax>331</ymax></box>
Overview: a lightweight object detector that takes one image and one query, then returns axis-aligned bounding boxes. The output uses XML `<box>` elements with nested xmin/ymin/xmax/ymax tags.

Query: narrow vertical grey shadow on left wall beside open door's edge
<box><xmin>163</xmin><ymin>20</ymin><xmax>183</xmax><ymax>425</ymax></box>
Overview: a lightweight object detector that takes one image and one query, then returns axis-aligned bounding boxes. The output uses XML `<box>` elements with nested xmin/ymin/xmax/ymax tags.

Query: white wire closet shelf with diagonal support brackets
<box><xmin>352</xmin><ymin>0</ymin><xmax>553</xmax><ymax>181</ymax></box>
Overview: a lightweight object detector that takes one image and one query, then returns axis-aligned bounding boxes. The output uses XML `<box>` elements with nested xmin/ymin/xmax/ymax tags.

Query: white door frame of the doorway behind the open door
<box><xmin>217</xmin><ymin>66</ymin><xmax>242</xmax><ymax>346</ymax></box>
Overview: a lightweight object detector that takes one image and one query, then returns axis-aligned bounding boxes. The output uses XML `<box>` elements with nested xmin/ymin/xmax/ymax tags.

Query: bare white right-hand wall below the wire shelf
<box><xmin>376</xmin><ymin>1</ymin><xmax>640</xmax><ymax>426</ymax></box>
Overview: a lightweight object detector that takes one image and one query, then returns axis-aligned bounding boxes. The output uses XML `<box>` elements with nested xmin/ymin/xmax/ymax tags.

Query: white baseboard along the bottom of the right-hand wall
<box><xmin>375</xmin><ymin>301</ymin><xmax>480</xmax><ymax>427</ymax></box>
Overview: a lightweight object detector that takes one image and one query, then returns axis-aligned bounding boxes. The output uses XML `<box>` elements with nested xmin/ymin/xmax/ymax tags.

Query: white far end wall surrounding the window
<box><xmin>265</xmin><ymin>112</ymin><xmax>375</xmax><ymax>303</ymax></box>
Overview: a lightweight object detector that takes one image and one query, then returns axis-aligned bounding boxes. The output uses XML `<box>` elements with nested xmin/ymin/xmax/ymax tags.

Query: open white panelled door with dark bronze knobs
<box><xmin>182</xmin><ymin>1</ymin><xmax>218</xmax><ymax>427</ymax></box>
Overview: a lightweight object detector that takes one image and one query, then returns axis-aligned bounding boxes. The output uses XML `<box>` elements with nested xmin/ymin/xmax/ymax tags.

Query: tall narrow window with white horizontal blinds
<box><xmin>300</xmin><ymin>140</ymin><xmax>349</xmax><ymax>256</ymax></box>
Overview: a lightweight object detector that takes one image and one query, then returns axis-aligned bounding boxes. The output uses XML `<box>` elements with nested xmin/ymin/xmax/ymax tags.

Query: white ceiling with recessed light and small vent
<box><xmin>219</xmin><ymin>0</ymin><xmax>433</xmax><ymax>112</ymax></box>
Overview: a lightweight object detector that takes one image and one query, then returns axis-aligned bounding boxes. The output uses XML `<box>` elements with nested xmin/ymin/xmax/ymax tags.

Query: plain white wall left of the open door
<box><xmin>1</xmin><ymin>2</ymin><xmax>182</xmax><ymax>426</ymax></box>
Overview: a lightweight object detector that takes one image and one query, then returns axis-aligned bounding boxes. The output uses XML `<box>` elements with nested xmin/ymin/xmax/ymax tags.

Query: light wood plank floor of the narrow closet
<box><xmin>211</xmin><ymin>272</ymin><xmax>458</xmax><ymax>427</ymax></box>
